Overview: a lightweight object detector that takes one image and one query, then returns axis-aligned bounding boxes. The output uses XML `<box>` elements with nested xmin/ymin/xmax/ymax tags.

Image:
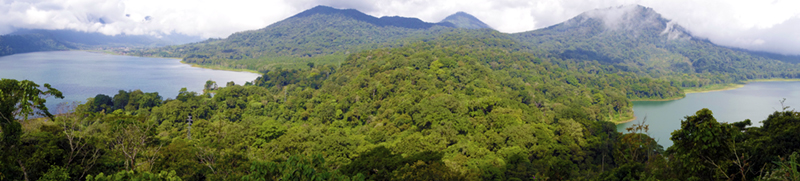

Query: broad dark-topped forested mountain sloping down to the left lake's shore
<box><xmin>135</xmin><ymin>6</ymin><xmax>462</xmax><ymax>71</ymax></box>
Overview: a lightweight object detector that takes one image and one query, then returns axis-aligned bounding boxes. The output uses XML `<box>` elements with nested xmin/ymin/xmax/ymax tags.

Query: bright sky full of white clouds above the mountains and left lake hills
<box><xmin>0</xmin><ymin>0</ymin><xmax>800</xmax><ymax>55</ymax></box>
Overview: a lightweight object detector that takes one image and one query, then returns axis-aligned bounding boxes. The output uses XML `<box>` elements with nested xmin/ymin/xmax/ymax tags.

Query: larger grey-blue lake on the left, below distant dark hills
<box><xmin>0</xmin><ymin>51</ymin><xmax>259</xmax><ymax>110</ymax></box>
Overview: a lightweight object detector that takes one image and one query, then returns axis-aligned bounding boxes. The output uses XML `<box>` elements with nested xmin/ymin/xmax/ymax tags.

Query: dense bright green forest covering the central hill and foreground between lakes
<box><xmin>0</xmin><ymin>33</ymin><xmax>800</xmax><ymax>180</ymax></box>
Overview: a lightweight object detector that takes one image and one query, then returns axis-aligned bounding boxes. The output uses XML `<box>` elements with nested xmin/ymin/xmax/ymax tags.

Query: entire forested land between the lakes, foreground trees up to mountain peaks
<box><xmin>0</xmin><ymin>5</ymin><xmax>800</xmax><ymax>180</ymax></box>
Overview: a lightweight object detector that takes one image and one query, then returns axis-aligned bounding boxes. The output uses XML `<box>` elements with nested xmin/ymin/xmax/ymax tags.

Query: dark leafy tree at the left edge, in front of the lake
<box><xmin>0</xmin><ymin>79</ymin><xmax>64</xmax><ymax>179</ymax></box>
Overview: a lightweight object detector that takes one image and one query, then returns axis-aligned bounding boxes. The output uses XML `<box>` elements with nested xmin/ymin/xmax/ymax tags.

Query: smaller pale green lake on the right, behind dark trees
<box><xmin>617</xmin><ymin>82</ymin><xmax>800</xmax><ymax>149</ymax></box>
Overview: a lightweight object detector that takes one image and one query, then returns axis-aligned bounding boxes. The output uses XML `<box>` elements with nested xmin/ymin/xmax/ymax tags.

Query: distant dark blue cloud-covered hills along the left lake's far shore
<box><xmin>0</xmin><ymin>29</ymin><xmax>201</xmax><ymax>56</ymax></box>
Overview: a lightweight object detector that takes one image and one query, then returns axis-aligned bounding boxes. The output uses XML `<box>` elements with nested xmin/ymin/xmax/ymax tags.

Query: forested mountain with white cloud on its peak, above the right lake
<box><xmin>513</xmin><ymin>5</ymin><xmax>800</xmax><ymax>87</ymax></box>
